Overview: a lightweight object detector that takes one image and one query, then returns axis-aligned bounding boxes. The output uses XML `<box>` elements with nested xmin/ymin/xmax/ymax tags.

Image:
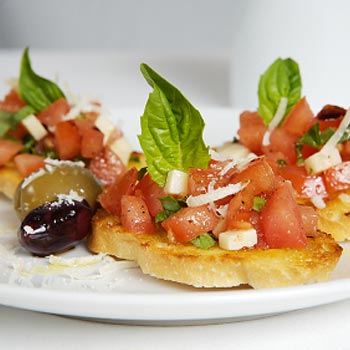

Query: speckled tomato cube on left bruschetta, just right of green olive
<box><xmin>89</xmin><ymin>147</ymin><xmax>126</xmax><ymax>186</ymax></box>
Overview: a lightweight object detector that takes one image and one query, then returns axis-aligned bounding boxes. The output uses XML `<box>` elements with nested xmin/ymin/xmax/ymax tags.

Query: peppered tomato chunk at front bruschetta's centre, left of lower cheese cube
<box><xmin>161</xmin><ymin>205</ymin><xmax>219</xmax><ymax>243</ymax></box>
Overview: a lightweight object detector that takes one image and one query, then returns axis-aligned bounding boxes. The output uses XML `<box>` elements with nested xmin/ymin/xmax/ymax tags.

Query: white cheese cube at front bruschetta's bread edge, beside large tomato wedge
<box><xmin>219</xmin><ymin>228</ymin><xmax>258</xmax><ymax>250</ymax></box>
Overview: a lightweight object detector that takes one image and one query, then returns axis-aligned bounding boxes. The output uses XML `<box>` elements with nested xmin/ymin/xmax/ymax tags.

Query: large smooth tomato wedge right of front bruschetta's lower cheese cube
<box><xmin>260</xmin><ymin>183</ymin><xmax>307</xmax><ymax>248</ymax></box>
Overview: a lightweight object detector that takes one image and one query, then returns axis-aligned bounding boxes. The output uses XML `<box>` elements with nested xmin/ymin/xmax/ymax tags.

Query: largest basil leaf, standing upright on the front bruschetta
<box><xmin>139</xmin><ymin>64</ymin><xmax>210</xmax><ymax>186</ymax></box>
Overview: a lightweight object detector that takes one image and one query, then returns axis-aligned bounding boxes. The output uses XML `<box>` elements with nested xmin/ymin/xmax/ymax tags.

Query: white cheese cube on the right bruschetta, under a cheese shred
<box><xmin>304</xmin><ymin>147</ymin><xmax>342</xmax><ymax>174</ymax></box>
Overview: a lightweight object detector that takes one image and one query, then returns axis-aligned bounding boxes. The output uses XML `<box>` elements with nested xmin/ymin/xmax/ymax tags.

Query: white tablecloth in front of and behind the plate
<box><xmin>0</xmin><ymin>50</ymin><xmax>350</xmax><ymax>350</ymax></box>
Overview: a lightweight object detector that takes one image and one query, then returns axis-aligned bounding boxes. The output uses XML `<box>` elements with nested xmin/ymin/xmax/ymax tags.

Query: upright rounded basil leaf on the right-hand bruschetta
<box><xmin>258</xmin><ymin>58</ymin><xmax>302</xmax><ymax>125</ymax></box>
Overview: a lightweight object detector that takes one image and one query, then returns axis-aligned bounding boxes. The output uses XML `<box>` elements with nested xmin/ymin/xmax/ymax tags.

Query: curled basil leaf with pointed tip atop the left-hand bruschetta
<box><xmin>18</xmin><ymin>48</ymin><xmax>64</xmax><ymax>112</ymax></box>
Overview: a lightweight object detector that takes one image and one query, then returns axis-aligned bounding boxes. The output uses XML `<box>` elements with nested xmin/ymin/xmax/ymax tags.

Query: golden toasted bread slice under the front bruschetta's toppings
<box><xmin>88</xmin><ymin>210</ymin><xmax>342</xmax><ymax>288</ymax></box>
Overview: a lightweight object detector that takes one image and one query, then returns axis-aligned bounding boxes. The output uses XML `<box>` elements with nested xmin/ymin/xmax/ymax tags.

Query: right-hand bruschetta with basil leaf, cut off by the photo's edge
<box><xmin>238</xmin><ymin>59</ymin><xmax>350</xmax><ymax>241</ymax></box>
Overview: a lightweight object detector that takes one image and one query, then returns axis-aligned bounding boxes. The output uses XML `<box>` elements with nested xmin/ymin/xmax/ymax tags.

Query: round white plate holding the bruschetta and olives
<box><xmin>0</xmin><ymin>109</ymin><xmax>350</xmax><ymax>325</ymax></box>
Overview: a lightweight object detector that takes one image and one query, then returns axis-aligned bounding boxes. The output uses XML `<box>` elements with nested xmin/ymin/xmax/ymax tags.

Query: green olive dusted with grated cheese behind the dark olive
<box><xmin>14</xmin><ymin>162</ymin><xmax>102</xmax><ymax>220</ymax></box>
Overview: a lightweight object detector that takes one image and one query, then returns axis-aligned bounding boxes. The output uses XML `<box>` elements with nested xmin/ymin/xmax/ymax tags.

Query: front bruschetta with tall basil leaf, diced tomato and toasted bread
<box><xmin>88</xmin><ymin>64</ymin><xmax>342</xmax><ymax>288</ymax></box>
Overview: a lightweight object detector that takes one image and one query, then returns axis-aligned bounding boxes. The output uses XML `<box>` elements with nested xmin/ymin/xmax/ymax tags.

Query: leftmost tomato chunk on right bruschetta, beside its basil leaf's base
<box><xmin>237</xmin><ymin>111</ymin><xmax>267</xmax><ymax>155</ymax></box>
